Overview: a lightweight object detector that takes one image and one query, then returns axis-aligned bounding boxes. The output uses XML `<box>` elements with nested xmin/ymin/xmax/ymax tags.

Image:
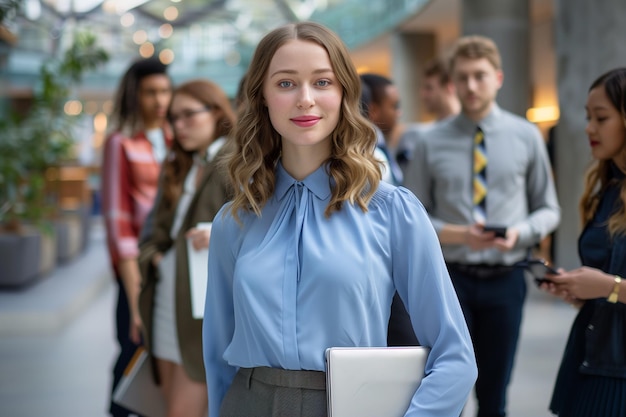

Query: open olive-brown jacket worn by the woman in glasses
<box><xmin>139</xmin><ymin>145</ymin><xmax>232</xmax><ymax>382</ymax></box>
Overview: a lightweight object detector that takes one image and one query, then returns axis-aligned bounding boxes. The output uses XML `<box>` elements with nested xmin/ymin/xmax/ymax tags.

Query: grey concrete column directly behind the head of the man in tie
<box><xmin>461</xmin><ymin>0</ymin><xmax>531</xmax><ymax>117</ymax></box>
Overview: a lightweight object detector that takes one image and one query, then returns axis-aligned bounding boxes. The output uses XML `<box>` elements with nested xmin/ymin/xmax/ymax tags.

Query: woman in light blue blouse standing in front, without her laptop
<box><xmin>203</xmin><ymin>22</ymin><xmax>476</xmax><ymax>417</ymax></box>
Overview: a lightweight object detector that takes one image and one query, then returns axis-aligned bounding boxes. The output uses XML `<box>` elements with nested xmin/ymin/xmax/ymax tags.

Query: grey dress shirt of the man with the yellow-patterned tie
<box><xmin>404</xmin><ymin>104</ymin><xmax>561</xmax><ymax>265</ymax></box>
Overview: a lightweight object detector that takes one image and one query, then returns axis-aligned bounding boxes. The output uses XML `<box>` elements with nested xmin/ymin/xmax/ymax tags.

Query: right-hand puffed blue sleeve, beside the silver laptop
<box><xmin>390</xmin><ymin>188</ymin><xmax>477</xmax><ymax>417</ymax></box>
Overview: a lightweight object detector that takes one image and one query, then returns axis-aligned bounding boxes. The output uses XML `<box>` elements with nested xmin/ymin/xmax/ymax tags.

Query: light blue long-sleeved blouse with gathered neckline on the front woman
<box><xmin>203</xmin><ymin>164</ymin><xmax>477</xmax><ymax>417</ymax></box>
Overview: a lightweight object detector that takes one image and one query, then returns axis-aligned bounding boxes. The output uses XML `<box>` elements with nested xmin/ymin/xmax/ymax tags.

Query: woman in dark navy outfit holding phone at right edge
<box><xmin>543</xmin><ymin>68</ymin><xmax>626</xmax><ymax>417</ymax></box>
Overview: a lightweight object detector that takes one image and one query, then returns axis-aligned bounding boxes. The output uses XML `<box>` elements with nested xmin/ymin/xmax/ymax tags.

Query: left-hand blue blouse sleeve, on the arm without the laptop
<box><xmin>202</xmin><ymin>204</ymin><xmax>239</xmax><ymax>417</ymax></box>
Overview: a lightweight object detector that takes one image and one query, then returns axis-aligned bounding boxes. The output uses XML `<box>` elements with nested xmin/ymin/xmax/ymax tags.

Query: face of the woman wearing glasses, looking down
<box><xmin>169</xmin><ymin>94</ymin><xmax>217</xmax><ymax>152</ymax></box>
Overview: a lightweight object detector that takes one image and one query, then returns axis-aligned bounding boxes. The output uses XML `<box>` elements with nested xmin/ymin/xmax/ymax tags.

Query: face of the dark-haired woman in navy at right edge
<box><xmin>585</xmin><ymin>86</ymin><xmax>626</xmax><ymax>164</ymax></box>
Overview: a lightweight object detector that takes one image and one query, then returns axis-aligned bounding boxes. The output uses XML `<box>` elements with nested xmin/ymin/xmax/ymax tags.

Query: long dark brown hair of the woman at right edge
<box><xmin>579</xmin><ymin>68</ymin><xmax>626</xmax><ymax>236</ymax></box>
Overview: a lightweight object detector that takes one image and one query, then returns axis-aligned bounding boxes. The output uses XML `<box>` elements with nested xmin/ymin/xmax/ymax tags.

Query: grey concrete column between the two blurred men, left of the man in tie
<box><xmin>390</xmin><ymin>32</ymin><xmax>437</xmax><ymax>123</ymax></box>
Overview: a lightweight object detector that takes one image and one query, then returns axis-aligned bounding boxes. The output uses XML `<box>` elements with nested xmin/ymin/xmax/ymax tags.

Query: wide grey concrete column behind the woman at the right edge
<box><xmin>555</xmin><ymin>0</ymin><xmax>626</xmax><ymax>268</ymax></box>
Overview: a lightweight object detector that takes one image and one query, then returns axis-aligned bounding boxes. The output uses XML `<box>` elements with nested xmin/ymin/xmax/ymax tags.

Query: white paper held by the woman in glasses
<box><xmin>187</xmin><ymin>222</ymin><xmax>211</xmax><ymax>319</ymax></box>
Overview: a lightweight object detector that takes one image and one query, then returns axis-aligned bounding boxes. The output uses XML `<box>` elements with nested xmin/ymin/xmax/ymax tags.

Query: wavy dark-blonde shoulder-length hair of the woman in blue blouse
<box><xmin>226</xmin><ymin>22</ymin><xmax>381</xmax><ymax>221</ymax></box>
